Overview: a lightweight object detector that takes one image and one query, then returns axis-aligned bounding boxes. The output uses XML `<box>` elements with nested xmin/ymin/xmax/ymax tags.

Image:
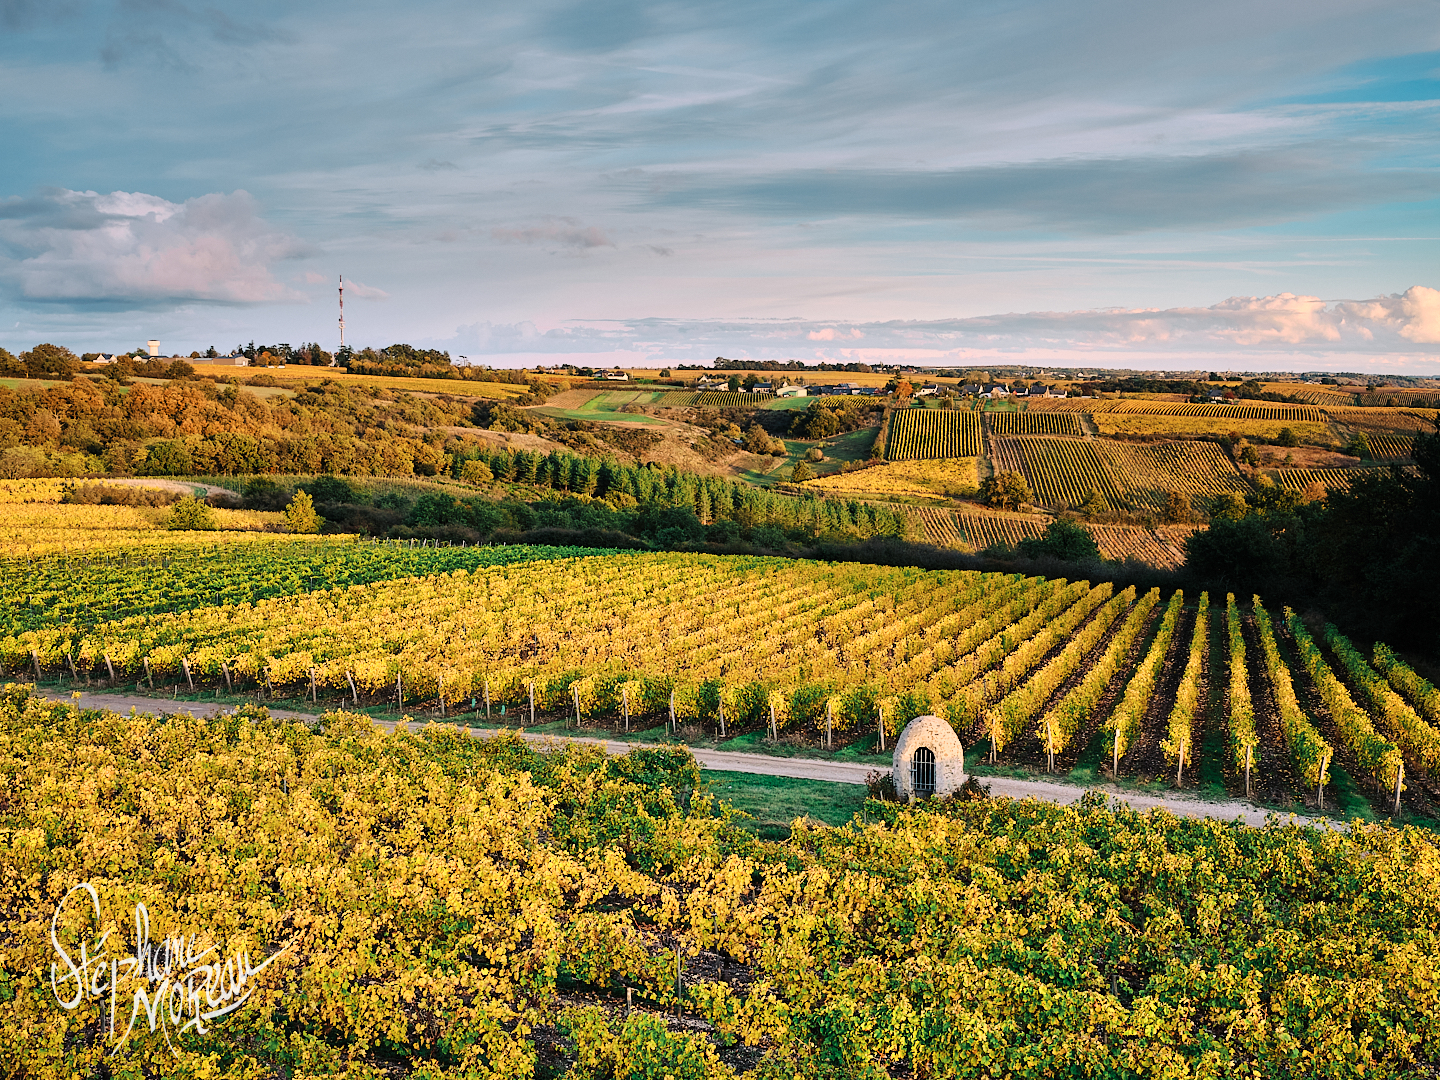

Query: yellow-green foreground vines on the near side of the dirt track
<box><xmin>11</xmin><ymin>694</ymin><xmax>1440</xmax><ymax>1080</ymax></box>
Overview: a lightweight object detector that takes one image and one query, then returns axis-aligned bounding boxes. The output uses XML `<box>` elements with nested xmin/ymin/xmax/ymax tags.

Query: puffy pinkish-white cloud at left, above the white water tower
<box><xmin>0</xmin><ymin>189</ymin><xmax>305</xmax><ymax>307</ymax></box>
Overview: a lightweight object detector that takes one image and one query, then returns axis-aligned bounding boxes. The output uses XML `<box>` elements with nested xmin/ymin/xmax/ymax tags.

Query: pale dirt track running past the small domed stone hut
<box><xmin>39</xmin><ymin>691</ymin><xmax>1313</xmax><ymax>828</ymax></box>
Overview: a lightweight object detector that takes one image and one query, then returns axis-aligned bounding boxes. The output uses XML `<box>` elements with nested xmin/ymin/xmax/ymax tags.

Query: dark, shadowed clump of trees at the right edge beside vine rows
<box><xmin>1187</xmin><ymin>426</ymin><xmax>1440</xmax><ymax>654</ymax></box>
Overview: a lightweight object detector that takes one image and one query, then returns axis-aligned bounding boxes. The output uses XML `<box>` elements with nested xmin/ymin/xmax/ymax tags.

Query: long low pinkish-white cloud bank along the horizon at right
<box><xmin>446</xmin><ymin>285</ymin><xmax>1440</xmax><ymax>370</ymax></box>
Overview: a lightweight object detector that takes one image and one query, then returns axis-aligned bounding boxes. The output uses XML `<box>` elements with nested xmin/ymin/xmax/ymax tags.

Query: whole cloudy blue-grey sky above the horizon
<box><xmin>0</xmin><ymin>0</ymin><xmax>1440</xmax><ymax>374</ymax></box>
